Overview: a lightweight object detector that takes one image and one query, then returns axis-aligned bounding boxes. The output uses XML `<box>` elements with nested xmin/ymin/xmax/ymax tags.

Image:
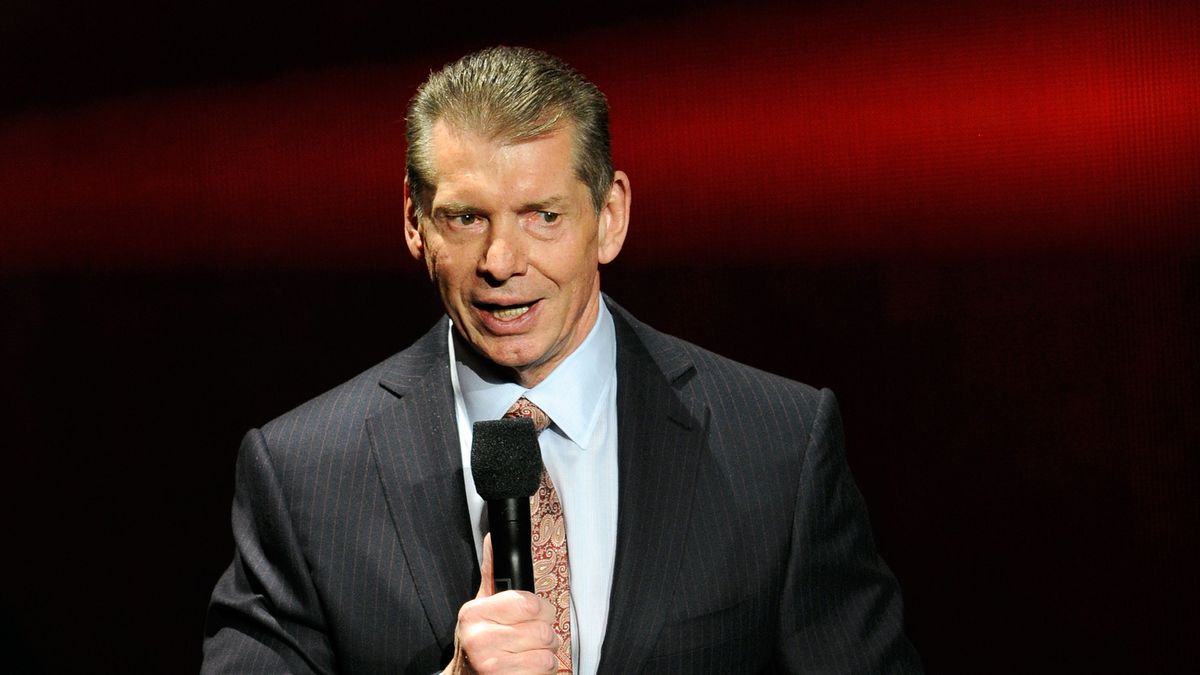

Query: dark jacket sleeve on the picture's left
<box><xmin>202</xmin><ymin>430</ymin><xmax>336</xmax><ymax>674</ymax></box>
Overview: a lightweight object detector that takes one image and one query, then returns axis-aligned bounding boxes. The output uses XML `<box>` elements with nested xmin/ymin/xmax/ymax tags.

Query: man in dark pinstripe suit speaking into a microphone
<box><xmin>204</xmin><ymin>48</ymin><xmax>919</xmax><ymax>674</ymax></box>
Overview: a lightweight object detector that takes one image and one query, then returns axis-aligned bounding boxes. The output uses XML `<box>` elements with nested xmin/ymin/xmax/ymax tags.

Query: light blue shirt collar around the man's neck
<box><xmin>449</xmin><ymin>299</ymin><xmax>617</xmax><ymax>448</ymax></box>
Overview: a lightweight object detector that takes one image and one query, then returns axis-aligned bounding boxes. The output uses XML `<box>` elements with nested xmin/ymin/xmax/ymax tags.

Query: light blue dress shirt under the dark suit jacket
<box><xmin>448</xmin><ymin>300</ymin><xmax>617</xmax><ymax>675</ymax></box>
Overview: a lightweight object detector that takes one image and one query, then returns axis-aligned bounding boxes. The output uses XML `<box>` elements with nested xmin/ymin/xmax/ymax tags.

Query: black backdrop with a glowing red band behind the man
<box><xmin>0</xmin><ymin>0</ymin><xmax>1200</xmax><ymax>673</ymax></box>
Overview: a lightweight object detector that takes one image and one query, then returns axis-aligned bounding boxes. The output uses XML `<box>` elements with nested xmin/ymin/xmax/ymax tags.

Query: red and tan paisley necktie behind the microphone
<box><xmin>504</xmin><ymin>396</ymin><xmax>571</xmax><ymax>673</ymax></box>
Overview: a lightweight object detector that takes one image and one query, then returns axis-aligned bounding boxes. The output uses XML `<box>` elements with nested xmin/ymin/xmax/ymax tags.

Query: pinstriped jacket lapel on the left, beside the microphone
<box><xmin>367</xmin><ymin>321</ymin><xmax>479</xmax><ymax>649</ymax></box>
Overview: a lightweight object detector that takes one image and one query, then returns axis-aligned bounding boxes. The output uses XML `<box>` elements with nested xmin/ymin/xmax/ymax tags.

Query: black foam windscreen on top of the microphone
<box><xmin>470</xmin><ymin>417</ymin><xmax>541</xmax><ymax>500</ymax></box>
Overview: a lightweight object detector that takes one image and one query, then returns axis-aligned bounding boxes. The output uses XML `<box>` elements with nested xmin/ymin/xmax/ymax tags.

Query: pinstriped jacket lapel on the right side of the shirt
<box><xmin>600</xmin><ymin>304</ymin><xmax>708</xmax><ymax>673</ymax></box>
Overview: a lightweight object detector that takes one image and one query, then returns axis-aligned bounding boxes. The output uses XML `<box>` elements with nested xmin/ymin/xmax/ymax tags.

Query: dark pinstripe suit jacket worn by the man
<box><xmin>204</xmin><ymin>301</ymin><xmax>919</xmax><ymax>674</ymax></box>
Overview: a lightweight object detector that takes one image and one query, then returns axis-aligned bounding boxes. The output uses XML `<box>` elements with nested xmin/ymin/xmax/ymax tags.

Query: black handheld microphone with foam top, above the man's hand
<box><xmin>470</xmin><ymin>417</ymin><xmax>541</xmax><ymax>592</ymax></box>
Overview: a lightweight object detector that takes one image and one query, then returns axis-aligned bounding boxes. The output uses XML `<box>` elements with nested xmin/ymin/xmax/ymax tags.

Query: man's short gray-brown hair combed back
<box><xmin>407</xmin><ymin>47</ymin><xmax>613</xmax><ymax>216</ymax></box>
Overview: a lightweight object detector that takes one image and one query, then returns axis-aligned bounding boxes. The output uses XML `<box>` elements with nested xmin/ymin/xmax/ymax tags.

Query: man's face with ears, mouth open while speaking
<box><xmin>404</xmin><ymin>121</ymin><xmax>629</xmax><ymax>387</ymax></box>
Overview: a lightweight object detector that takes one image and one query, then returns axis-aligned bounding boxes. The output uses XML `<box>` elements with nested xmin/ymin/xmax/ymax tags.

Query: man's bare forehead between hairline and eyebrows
<box><xmin>430</xmin><ymin>121</ymin><xmax>587</xmax><ymax>203</ymax></box>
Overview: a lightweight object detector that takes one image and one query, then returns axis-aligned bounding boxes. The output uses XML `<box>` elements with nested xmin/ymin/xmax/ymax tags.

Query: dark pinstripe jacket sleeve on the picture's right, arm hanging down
<box><xmin>779</xmin><ymin>389</ymin><xmax>922</xmax><ymax>674</ymax></box>
